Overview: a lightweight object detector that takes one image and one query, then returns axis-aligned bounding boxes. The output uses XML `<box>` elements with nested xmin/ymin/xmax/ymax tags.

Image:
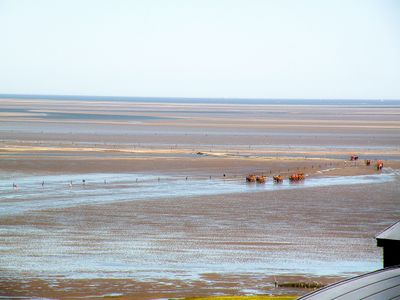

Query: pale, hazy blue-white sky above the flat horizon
<box><xmin>0</xmin><ymin>0</ymin><xmax>400</xmax><ymax>99</ymax></box>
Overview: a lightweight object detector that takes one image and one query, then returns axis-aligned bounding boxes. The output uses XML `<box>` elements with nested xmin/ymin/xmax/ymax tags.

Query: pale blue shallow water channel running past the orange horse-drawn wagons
<box><xmin>0</xmin><ymin>169</ymin><xmax>400</xmax><ymax>216</ymax></box>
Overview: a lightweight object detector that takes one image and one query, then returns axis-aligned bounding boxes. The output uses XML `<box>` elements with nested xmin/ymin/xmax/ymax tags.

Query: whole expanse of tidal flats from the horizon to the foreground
<box><xmin>0</xmin><ymin>99</ymin><xmax>400</xmax><ymax>299</ymax></box>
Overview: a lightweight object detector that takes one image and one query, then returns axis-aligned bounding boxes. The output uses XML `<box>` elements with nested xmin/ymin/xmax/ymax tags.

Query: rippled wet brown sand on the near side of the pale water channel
<box><xmin>0</xmin><ymin>172</ymin><xmax>400</xmax><ymax>299</ymax></box>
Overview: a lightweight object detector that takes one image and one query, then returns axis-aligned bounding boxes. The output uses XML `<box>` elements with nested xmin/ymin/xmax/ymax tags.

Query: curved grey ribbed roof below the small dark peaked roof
<box><xmin>299</xmin><ymin>266</ymin><xmax>400</xmax><ymax>300</ymax></box>
